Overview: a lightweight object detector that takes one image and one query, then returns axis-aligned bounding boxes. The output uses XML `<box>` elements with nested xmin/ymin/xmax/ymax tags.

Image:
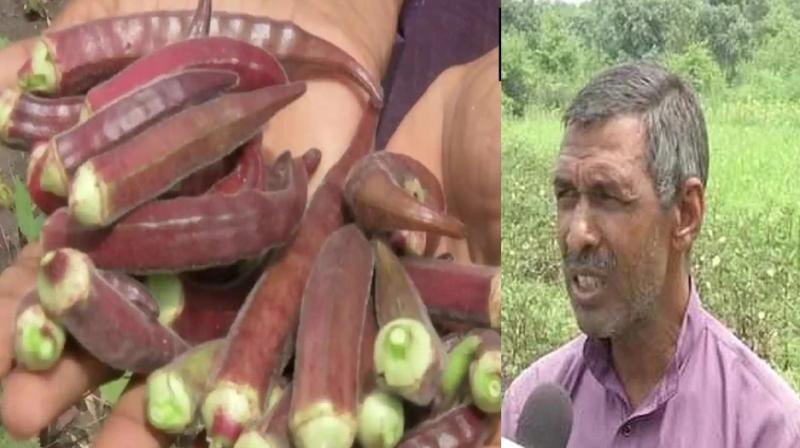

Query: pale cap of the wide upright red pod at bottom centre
<box><xmin>291</xmin><ymin>401</ymin><xmax>358</xmax><ymax>448</ymax></box>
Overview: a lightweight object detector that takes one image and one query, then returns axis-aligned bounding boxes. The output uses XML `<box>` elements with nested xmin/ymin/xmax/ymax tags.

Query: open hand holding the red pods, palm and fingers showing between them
<box><xmin>0</xmin><ymin>0</ymin><xmax>401</xmax><ymax>448</ymax></box>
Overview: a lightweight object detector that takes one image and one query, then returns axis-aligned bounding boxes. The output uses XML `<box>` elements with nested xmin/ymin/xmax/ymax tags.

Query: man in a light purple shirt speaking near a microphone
<box><xmin>502</xmin><ymin>63</ymin><xmax>800</xmax><ymax>448</ymax></box>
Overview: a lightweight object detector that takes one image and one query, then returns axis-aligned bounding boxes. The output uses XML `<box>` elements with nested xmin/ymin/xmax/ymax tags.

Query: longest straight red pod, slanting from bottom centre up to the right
<box><xmin>198</xmin><ymin>109</ymin><xmax>377</xmax><ymax>446</ymax></box>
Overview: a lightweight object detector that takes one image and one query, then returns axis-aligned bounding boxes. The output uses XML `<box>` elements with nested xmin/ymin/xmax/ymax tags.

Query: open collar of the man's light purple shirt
<box><xmin>583</xmin><ymin>276</ymin><xmax>706</xmax><ymax>415</ymax></box>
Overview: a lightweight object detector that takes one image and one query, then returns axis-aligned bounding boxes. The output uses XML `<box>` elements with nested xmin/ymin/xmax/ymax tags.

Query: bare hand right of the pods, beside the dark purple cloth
<box><xmin>386</xmin><ymin>48</ymin><xmax>501</xmax><ymax>266</ymax></box>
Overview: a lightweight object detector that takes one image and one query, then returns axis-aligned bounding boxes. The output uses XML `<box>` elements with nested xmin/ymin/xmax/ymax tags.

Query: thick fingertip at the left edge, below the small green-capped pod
<box><xmin>0</xmin><ymin>351</ymin><xmax>114</xmax><ymax>439</ymax></box>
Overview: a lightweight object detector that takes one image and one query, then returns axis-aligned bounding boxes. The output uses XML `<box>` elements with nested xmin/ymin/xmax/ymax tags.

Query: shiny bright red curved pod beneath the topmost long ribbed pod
<box><xmin>86</xmin><ymin>36</ymin><xmax>287</xmax><ymax>112</ymax></box>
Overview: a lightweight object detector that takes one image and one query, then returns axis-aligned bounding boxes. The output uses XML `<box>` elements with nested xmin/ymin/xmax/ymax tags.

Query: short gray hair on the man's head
<box><xmin>563</xmin><ymin>62</ymin><xmax>708</xmax><ymax>207</ymax></box>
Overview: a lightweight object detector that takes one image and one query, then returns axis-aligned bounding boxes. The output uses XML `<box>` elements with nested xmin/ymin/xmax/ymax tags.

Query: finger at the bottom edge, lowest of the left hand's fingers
<box><xmin>92</xmin><ymin>379</ymin><xmax>174</xmax><ymax>448</ymax></box>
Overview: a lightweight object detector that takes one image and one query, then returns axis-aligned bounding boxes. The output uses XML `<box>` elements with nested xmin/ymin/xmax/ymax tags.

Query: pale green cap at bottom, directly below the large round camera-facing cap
<box><xmin>358</xmin><ymin>390</ymin><xmax>405</xmax><ymax>448</ymax></box>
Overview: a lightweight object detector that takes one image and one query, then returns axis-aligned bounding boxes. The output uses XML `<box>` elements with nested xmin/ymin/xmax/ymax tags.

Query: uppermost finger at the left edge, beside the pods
<box><xmin>0</xmin><ymin>243</ymin><xmax>42</xmax><ymax>378</ymax></box>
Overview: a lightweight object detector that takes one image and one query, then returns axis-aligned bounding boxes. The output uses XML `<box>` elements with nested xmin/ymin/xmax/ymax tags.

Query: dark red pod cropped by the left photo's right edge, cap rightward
<box><xmin>401</xmin><ymin>257</ymin><xmax>501</xmax><ymax>328</ymax></box>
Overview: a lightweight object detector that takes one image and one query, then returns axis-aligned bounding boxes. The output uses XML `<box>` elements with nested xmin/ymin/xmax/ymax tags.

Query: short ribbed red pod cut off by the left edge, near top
<box><xmin>0</xmin><ymin>89</ymin><xmax>83</xmax><ymax>151</ymax></box>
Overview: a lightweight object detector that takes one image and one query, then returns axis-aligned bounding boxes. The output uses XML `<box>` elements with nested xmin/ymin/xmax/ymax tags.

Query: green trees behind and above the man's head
<box><xmin>501</xmin><ymin>0</ymin><xmax>800</xmax><ymax>115</ymax></box>
